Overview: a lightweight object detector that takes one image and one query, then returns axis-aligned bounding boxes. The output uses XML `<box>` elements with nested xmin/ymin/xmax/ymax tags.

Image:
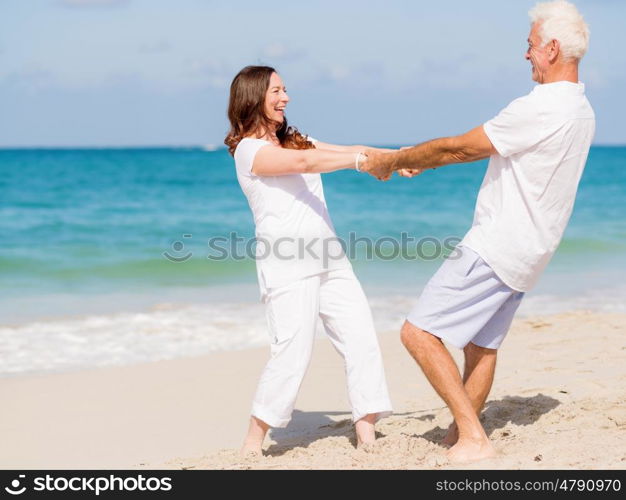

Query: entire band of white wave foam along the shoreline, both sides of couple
<box><xmin>0</xmin><ymin>287</ymin><xmax>626</xmax><ymax>376</ymax></box>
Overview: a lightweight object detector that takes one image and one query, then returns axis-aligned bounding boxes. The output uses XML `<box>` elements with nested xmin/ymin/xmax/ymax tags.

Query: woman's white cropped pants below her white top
<box><xmin>252</xmin><ymin>268</ymin><xmax>391</xmax><ymax>427</ymax></box>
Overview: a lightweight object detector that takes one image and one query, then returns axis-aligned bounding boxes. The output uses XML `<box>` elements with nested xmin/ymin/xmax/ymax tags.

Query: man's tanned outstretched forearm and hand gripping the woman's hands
<box><xmin>363</xmin><ymin>125</ymin><xmax>497</xmax><ymax>180</ymax></box>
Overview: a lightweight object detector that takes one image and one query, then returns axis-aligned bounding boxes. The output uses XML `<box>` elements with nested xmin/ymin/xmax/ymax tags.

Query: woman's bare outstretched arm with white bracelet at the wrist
<box><xmin>252</xmin><ymin>145</ymin><xmax>367</xmax><ymax>177</ymax></box>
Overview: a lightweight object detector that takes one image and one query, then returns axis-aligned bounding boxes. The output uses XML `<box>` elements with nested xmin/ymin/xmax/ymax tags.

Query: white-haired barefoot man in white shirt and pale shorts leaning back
<box><xmin>363</xmin><ymin>0</ymin><xmax>595</xmax><ymax>462</ymax></box>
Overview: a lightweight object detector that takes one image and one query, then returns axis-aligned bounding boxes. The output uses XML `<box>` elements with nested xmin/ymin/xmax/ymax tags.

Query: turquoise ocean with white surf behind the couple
<box><xmin>0</xmin><ymin>146</ymin><xmax>626</xmax><ymax>376</ymax></box>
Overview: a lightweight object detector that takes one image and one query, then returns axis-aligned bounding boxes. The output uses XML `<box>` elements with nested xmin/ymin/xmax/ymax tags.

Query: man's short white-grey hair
<box><xmin>528</xmin><ymin>0</ymin><xmax>589</xmax><ymax>59</ymax></box>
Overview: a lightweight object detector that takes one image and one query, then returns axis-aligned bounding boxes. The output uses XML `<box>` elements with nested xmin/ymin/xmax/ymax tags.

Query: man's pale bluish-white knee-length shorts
<box><xmin>407</xmin><ymin>246</ymin><xmax>524</xmax><ymax>349</ymax></box>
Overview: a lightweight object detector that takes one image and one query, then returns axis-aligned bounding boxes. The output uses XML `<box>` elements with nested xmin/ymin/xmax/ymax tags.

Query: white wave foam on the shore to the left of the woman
<box><xmin>0</xmin><ymin>303</ymin><xmax>267</xmax><ymax>375</ymax></box>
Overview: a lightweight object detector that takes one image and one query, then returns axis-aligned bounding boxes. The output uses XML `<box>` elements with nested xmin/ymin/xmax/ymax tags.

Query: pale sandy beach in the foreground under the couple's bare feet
<box><xmin>0</xmin><ymin>311</ymin><xmax>626</xmax><ymax>469</ymax></box>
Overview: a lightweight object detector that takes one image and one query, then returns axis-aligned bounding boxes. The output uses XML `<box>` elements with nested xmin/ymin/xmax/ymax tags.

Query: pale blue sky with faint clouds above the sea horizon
<box><xmin>0</xmin><ymin>0</ymin><xmax>626</xmax><ymax>147</ymax></box>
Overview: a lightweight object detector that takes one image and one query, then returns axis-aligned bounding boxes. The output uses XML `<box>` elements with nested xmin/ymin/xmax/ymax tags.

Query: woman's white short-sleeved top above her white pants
<box><xmin>234</xmin><ymin>138</ymin><xmax>351</xmax><ymax>297</ymax></box>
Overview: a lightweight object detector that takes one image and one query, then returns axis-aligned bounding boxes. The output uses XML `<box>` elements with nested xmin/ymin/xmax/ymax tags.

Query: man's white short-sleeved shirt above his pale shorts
<box><xmin>461</xmin><ymin>81</ymin><xmax>595</xmax><ymax>291</ymax></box>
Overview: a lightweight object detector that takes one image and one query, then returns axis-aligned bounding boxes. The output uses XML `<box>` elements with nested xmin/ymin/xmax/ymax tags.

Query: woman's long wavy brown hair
<box><xmin>224</xmin><ymin>66</ymin><xmax>315</xmax><ymax>155</ymax></box>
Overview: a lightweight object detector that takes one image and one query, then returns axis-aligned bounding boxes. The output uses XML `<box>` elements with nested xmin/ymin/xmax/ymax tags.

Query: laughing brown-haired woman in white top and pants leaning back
<box><xmin>224</xmin><ymin>66</ymin><xmax>391</xmax><ymax>455</ymax></box>
